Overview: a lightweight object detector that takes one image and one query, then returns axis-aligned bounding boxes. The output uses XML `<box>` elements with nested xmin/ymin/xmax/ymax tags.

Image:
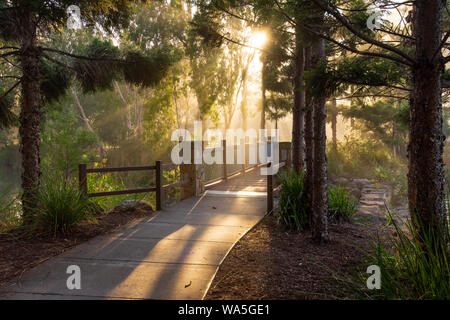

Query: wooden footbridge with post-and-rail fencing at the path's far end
<box><xmin>79</xmin><ymin>140</ymin><xmax>291</xmax><ymax>212</ymax></box>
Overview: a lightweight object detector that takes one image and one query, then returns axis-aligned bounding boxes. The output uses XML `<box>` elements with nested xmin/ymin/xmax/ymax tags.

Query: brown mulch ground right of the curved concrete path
<box><xmin>206</xmin><ymin>216</ymin><xmax>388</xmax><ymax>300</ymax></box>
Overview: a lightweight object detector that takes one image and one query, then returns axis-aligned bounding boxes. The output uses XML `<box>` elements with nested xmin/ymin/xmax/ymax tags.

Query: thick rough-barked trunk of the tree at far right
<box><xmin>408</xmin><ymin>0</ymin><xmax>448</xmax><ymax>240</ymax></box>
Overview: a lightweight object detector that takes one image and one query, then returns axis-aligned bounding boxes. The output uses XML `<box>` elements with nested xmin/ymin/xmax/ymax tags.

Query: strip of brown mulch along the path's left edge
<box><xmin>0</xmin><ymin>202</ymin><xmax>153</xmax><ymax>286</ymax></box>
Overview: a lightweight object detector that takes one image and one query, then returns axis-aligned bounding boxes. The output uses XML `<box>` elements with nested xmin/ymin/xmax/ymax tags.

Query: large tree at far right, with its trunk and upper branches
<box><xmin>306</xmin><ymin>0</ymin><xmax>450</xmax><ymax>241</ymax></box>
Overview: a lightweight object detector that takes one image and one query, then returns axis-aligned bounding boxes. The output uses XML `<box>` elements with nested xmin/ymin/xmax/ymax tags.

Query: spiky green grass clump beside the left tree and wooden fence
<box><xmin>34</xmin><ymin>176</ymin><xmax>96</xmax><ymax>234</ymax></box>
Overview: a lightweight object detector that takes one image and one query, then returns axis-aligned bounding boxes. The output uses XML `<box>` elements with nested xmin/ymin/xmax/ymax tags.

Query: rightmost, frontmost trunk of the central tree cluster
<box><xmin>312</xmin><ymin>39</ymin><xmax>328</xmax><ymax>243</ymax></box>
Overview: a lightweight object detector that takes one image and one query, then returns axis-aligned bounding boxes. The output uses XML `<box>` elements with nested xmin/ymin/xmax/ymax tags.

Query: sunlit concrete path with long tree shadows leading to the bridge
<box><xmin>0</xmin><ymin>192</ymin><xmax>266</xmax><ymax>300</ymax></box>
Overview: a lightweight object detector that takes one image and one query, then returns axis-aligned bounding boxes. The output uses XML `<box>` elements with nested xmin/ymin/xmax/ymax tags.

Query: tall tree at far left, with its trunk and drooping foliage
<box><xmin>0</xmin><ymin>0</ymin><xmax>174</xmax><ymax>223</ymax></box>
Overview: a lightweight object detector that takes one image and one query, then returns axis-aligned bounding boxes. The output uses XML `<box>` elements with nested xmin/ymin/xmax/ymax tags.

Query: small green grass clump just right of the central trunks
<box><xmin>328</xmin><ymin>186</ymin><xmax>357</xmax><ymax>222</ymax></box>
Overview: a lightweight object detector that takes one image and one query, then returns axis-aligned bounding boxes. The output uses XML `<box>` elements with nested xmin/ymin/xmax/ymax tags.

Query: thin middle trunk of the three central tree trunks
<box><xmin>305</xmin><ymin>46</ymin><xmax>314</xmax><ymax>220</ymax></box>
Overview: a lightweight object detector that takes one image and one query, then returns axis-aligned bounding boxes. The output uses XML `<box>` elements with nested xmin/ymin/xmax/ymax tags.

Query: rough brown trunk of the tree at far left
<box><xmin>19</xmin><ymin>14</ymin><xmax>41</xmax><ymax>224</ymax></box>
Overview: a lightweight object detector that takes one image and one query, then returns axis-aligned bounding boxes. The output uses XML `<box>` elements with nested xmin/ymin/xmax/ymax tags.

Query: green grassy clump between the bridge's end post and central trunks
<box><xmin>278</xmin><ymin>172</ymin><xmax>311</xmax><ymax>232</ymax></box>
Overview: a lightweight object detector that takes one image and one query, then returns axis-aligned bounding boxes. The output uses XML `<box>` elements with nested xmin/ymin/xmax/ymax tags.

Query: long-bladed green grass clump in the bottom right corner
<box><xmin>344</xmin><ymin>211</ymin><xmax>450</xmax><ymax>300</ymax></box>
